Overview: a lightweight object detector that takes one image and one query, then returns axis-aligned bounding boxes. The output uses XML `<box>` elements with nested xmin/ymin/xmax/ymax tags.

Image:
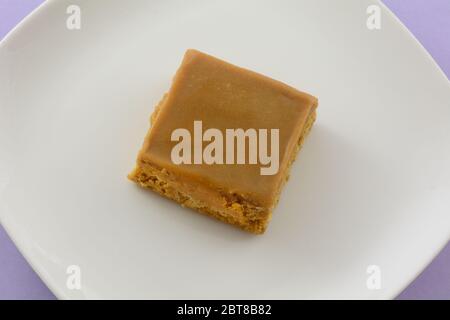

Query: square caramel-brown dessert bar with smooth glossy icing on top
<box><xmin>129</xmin><ymin>50</ymin><xmax>317</xmax><ymax>234</ymax></box>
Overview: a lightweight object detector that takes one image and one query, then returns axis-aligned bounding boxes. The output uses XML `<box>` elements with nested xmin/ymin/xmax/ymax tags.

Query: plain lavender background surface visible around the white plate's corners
<box><xmin>0</xmin><ymin>0</ymin><xmax>450</xmax><ymax>299</ymax></box>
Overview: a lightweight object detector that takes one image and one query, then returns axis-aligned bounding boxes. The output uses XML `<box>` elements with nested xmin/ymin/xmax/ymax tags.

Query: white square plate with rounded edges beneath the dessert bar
<box><xmin>0</xmin><ymin>0</ymin><xmax>450</xmax><ymax>298</ymax></box>
